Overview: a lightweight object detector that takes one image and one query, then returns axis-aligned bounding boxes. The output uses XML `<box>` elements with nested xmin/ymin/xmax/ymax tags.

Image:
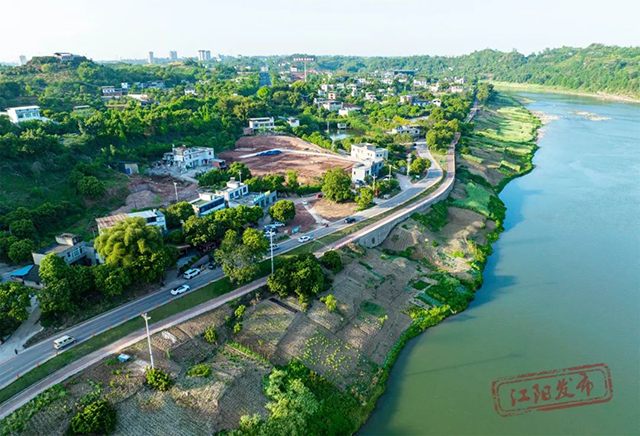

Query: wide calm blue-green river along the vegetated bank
<box><xmin>359</xmin><ymin>93</ymin><xmax>640</xmax><ymax>435</ymax></box>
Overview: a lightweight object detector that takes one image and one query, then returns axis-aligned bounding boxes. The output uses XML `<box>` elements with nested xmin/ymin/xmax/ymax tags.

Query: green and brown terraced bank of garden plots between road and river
<box><xmin>2</xmin><ymin>89</ymin><xmax>540</xmax><ymax>436</ymax></box>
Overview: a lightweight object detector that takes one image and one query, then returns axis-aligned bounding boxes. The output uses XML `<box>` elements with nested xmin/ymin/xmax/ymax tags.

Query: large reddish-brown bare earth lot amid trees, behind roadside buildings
<box><xmin>219</xmin><ymin>136</ymin><xmax>353</xmax><ymax>183</ymax></box>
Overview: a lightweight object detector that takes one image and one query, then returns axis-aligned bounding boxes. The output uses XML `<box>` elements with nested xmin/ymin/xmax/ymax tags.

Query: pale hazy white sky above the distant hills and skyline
<box><xmin>0</xmin><ymin>0</ymin><xmax>640</xmax><ymax>61</ymax></box>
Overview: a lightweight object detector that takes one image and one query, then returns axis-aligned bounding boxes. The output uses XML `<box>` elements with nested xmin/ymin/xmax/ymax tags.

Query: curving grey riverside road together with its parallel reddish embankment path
<box><xmin>0</xmin><ymin>103</ymin><xmax>477</xmax><ymax>418</ymax></box>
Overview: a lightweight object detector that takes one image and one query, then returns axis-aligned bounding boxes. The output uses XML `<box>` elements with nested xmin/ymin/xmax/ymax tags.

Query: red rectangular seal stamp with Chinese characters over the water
<box><xmin>491</xmin><ymin>363</ymin><xmax>613</xmax><ymax>416</ymax></box>
